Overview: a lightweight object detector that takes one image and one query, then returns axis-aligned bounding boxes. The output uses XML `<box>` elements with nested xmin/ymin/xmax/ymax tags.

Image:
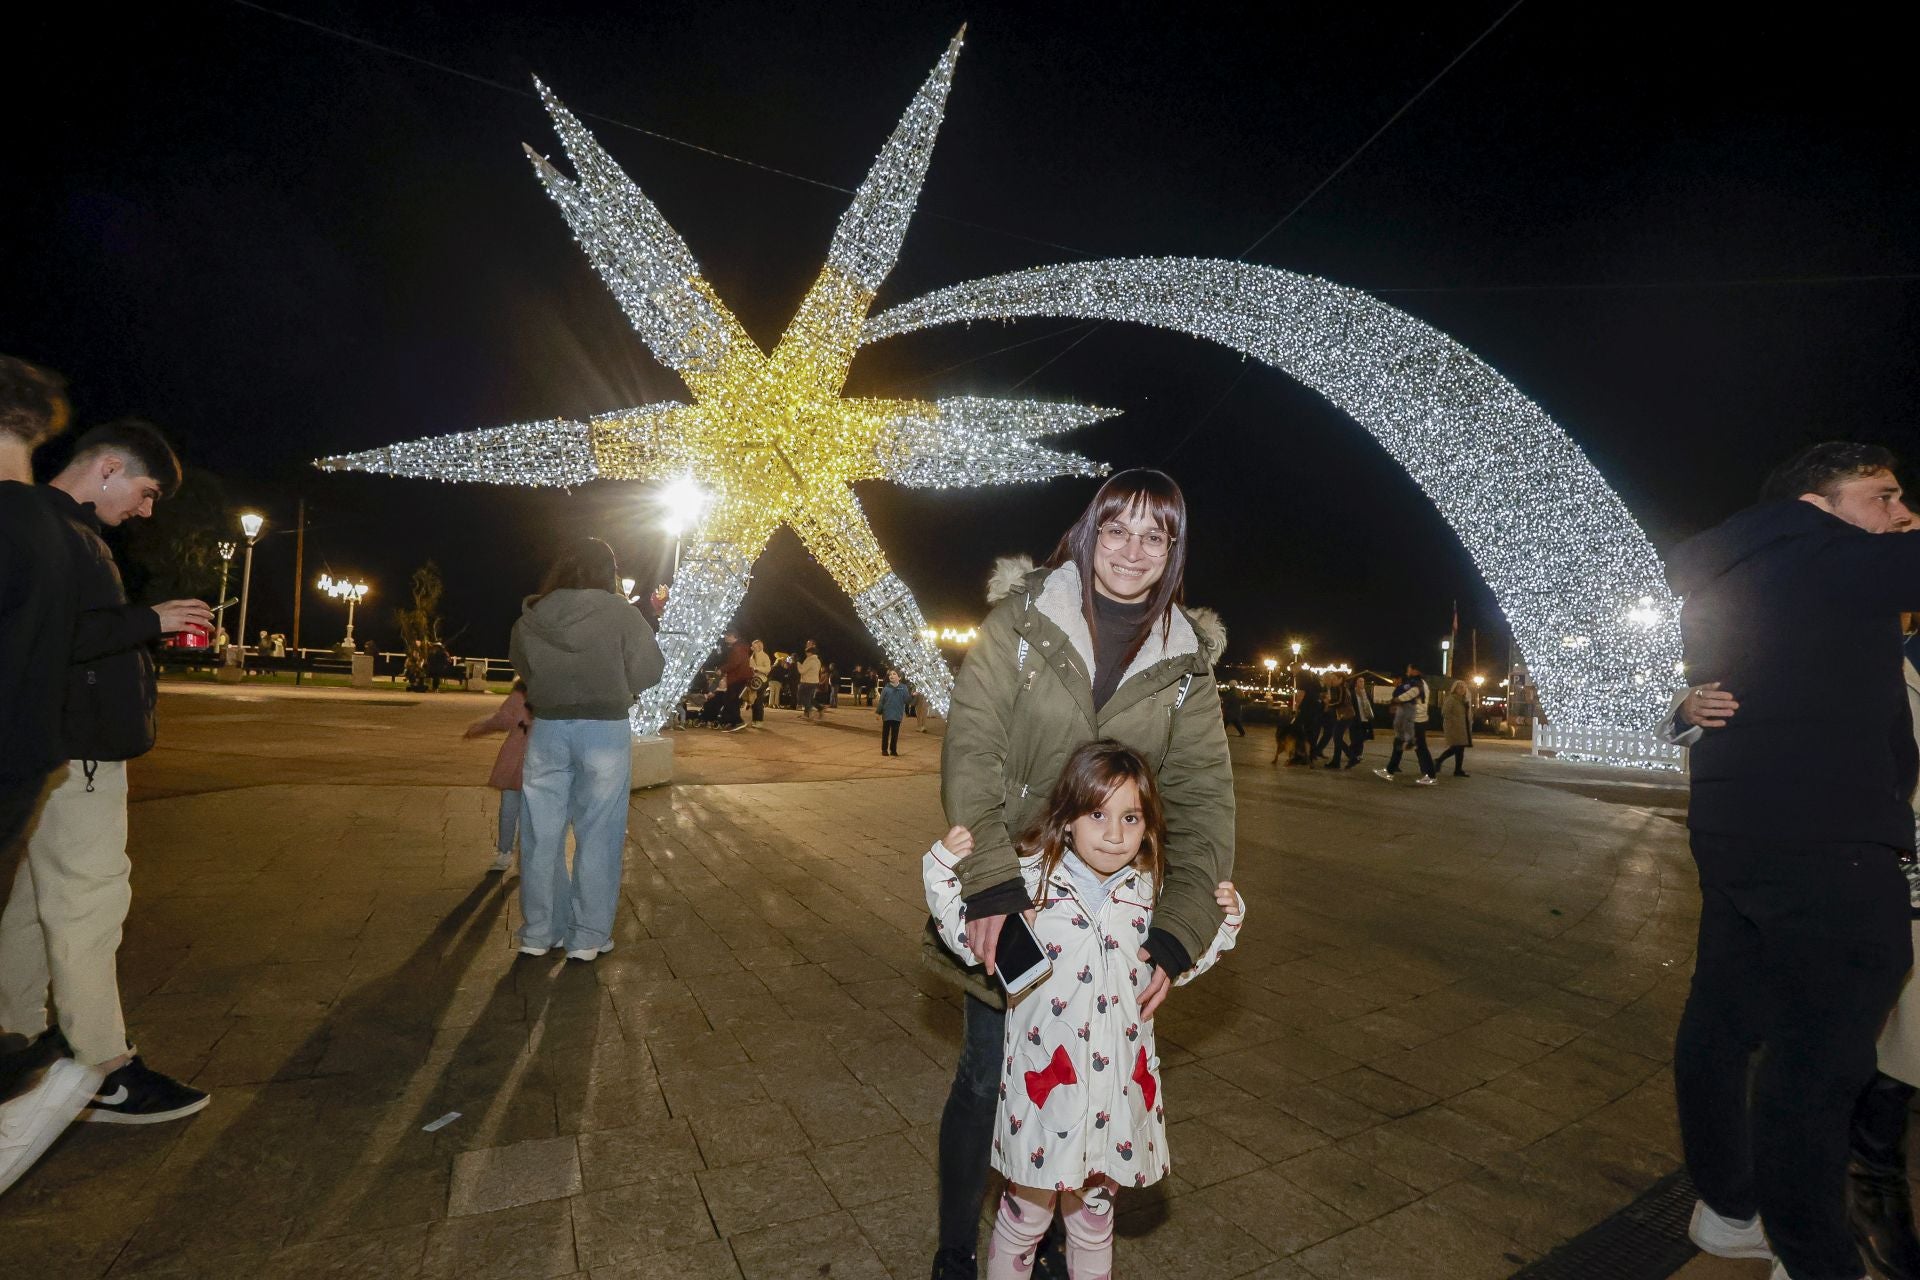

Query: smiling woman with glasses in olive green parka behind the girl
<box><xmin>927</xmin><ymin>470</ymin><xmax>1233</xmax><ymax>1280</ymax></box>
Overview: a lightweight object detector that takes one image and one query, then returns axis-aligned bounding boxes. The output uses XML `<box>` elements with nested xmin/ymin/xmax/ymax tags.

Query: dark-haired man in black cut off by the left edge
<box><xmin>0</xmin><ymin>355</ymin><xmax>102</xmax><ymax>1192</ymax></box>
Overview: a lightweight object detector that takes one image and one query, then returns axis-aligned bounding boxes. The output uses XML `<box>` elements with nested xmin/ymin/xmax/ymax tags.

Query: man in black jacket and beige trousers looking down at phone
<box><xmin>0</xmin><ymin>422</ymin><xmax>213</xmax><ymax>1125</ymax></box>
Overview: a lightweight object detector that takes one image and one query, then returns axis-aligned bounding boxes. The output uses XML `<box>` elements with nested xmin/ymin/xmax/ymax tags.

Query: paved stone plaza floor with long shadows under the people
<box><xmin>0</xmin><ymin>687</ymin><xmax>1764</xmax><ymax>1280</ymax></box>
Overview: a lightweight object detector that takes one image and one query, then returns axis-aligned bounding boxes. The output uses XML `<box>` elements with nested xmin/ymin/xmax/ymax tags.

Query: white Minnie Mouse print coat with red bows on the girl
<box><xmin>922</xmin><ymin>842</ymin><xmax>1246</xmax><ymax>1190</ymax></box>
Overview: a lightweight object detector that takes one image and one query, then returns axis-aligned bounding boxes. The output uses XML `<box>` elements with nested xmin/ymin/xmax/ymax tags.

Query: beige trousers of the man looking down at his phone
<box><xmin>0</xmin><ymin>760</ymin><xmax>132</xmax><ymax>1065</ymax></box>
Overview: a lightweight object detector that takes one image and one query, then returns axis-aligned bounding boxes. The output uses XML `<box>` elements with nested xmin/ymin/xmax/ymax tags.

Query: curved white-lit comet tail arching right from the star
<box><xmin>862</xmin><ymin>257</ymin><xmax>1680</xmax><ymax>740</ymax></box>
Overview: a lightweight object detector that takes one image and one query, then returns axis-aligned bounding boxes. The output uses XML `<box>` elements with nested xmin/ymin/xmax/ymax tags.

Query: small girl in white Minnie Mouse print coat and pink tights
<box><xmin>922</xmin><ymin>741</ymin><xmax>1246</xmax><ymax>1280</ymax></box>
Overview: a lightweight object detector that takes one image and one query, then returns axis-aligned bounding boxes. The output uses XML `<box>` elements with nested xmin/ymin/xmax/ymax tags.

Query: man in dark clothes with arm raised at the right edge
<box><xmin>1668</xmin><ymin>443</ymin><xmax>1920</xmax><ymax>1280</ymax></box>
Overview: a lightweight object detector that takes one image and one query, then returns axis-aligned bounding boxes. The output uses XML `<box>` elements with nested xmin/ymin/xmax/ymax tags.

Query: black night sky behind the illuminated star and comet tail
<box><xmin>0</xmin><ymin>0</ymin><xmax>1920</xmax><ymax>666</ymax></box>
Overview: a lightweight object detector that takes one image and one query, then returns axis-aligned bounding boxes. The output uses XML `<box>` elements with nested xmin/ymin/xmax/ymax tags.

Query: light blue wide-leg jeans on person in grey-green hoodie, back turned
<box><xmin>520</xmin><ymin>720</ymin><xmax>634</xmax><ymax>952</ymax></box>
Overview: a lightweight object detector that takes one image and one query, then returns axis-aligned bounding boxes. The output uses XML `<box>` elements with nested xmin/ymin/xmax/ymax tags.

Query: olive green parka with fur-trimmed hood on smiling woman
<box><xmin>925</xmin><ymin>557</ymin><xmax>1235</xmax><ymax>1007</ymax></box>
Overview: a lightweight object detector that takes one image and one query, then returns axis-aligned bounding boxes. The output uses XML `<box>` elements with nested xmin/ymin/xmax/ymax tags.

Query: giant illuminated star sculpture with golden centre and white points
<box><xmin>321</xmin><ymin>29</ymin><xmax>1112</xmax><ymax>733</ymax></box>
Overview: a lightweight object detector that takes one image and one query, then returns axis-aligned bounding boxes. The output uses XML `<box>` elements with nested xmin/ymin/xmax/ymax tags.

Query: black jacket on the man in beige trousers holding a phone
<box><xmin>48</xmin><ymin>489</ymin><xmax>159</xmax><ymax>760</ymax></box>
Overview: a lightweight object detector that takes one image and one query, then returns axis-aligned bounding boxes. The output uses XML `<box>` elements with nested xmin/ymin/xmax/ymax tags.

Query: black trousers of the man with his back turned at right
<box><xmin>1674</xmin><ymin>831</ymin><xmax>1912</xmax><ymax>1280</ymax></box>
